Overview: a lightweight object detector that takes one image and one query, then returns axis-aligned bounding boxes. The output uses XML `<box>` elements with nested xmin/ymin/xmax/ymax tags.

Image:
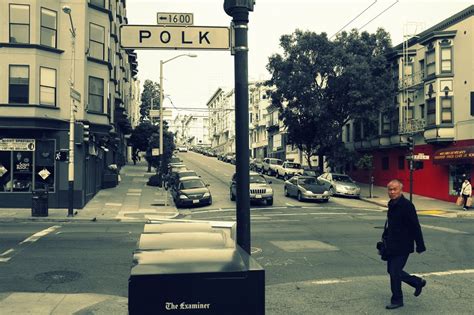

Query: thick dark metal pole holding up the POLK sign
<box><xmin>224</xmin><ymin>0</ymin><xmax>255</xmax><ymax>255</ymax></box>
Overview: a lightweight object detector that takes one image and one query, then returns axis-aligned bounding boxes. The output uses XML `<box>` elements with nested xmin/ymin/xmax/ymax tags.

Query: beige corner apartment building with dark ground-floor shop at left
<box><xmin>0</xmin><ymin>0</ymin><xmax>137</xmax><ymax>208</ymax></box>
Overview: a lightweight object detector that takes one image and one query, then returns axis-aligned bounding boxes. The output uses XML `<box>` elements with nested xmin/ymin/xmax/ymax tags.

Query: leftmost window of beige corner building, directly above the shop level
<box><xmin>8</xmin><ymin>66</ymin><xmax>30</xmax><ymax>104</ymax></box>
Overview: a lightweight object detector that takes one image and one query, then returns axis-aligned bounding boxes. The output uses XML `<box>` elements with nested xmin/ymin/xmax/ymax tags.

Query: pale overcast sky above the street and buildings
<box><xmin>127</xmin><ymin>0</ymin><xmax>474</xmax><ymax>114</ymax></box>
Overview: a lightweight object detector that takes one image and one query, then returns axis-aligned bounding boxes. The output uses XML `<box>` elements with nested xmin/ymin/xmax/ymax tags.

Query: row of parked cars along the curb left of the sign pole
<box><xmin>165</xmin><ymin>156</ymin><xmax>212</xmax><ymax>208</ymax></box>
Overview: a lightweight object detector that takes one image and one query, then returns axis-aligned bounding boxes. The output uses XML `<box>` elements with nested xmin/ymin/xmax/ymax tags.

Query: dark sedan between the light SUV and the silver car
<box><xmin>284</xmin><ymin>175</ymin><xmax>331</xmax><ymax>202</ymax></box>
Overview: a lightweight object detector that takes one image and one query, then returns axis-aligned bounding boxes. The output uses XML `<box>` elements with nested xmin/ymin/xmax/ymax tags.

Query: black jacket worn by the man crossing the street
<box><xmin>383</xmin><ymin>195</ymin><xmax>425</xmax><ymax>255</ymax></box>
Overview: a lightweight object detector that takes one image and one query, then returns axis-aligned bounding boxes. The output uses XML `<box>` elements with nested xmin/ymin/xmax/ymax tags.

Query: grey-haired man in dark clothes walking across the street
<box><xmin>382</xmin><ymin>179</ymin><xmax>426</xmax><ymax>309</ymax></box>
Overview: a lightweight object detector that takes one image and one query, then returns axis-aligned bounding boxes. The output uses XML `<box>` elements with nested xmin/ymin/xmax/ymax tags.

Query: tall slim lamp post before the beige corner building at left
<box><xmin>62</xmin><ymin>5</ymin><xmax>76</xmax><ymax>217</ymax></box>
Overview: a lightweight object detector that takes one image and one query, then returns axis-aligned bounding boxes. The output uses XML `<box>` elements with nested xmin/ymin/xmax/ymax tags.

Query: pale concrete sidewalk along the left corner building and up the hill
<box><xmin>0</xmin><ymin>161</ymin><xmax>179</xmax><ymax>222</ymax></box>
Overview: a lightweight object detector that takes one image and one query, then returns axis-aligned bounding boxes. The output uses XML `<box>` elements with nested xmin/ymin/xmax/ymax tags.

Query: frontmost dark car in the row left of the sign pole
<box><xmin>171</xmin><ymin>176</ymin><xmax>212</xmax><ymax>208</ymax></box>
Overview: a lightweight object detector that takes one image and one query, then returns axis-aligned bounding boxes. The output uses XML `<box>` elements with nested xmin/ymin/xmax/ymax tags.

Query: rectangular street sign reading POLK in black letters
<box><xmin>120</xmin><ymin>25</ymin><xmax>230</xmax><ymax>50</ymax></box>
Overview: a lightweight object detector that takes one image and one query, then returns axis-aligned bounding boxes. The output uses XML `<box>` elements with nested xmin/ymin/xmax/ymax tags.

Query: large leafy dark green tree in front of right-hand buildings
<box><xmin>267</xmin><ymin>29</ymin><xmax>395</xmax><ymax>169</ymax></box>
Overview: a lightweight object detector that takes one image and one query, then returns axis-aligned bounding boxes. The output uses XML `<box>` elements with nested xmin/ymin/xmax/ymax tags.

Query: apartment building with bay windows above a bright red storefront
<box><xmin>343</xmin><ymin>6</ymin><xmax>474</xmax><ymax>201</ymax></box>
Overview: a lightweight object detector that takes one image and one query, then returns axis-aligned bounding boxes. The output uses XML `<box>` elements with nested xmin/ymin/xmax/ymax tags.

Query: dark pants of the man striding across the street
<box><xmin>387</xmin><ymin>254</ymin><xmax>421</xmax><ymax>304</ymax></box>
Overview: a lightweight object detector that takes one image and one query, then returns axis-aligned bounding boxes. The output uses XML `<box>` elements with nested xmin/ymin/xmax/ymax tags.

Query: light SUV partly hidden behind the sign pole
<box><xmin>229</xmin><ymin>172</ymin><xmax>273</xmax><ymax>206</ymax></box>
